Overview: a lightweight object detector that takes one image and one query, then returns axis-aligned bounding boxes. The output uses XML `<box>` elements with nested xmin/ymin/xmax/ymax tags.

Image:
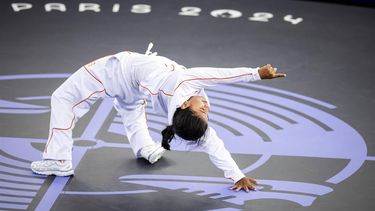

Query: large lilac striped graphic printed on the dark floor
<box><xmin>0</xmin><ymin>74</ymin><xmax>374</xmax><ymax>209</ymax></box>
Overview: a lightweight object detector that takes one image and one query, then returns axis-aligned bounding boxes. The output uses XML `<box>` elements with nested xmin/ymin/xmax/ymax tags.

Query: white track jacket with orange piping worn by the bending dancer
<box><xmin>107</xmin><ymin>52</ymin><xmax>260</xmax><ymax>182</ymax></box>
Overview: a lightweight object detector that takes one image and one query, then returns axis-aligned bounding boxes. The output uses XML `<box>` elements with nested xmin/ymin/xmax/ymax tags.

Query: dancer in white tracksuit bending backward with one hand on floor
<box><xmin>31</xmin><ymin>45</ymin><xmax>286</xmax><ymax>192</ymax></box>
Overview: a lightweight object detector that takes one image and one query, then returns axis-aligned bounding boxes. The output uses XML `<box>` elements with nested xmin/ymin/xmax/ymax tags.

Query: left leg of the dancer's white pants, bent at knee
<box><xmin>43</xmin><ymin>67</ymin><xmax>105</xmax><ymax>160</ymax></box>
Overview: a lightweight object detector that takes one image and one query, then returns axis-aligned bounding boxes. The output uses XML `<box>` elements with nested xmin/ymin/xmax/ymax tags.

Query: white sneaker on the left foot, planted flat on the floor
<box><xmin>31</xmin><ymin>160</ymin><xmax>74</xmax><ymax>176</ymax></box>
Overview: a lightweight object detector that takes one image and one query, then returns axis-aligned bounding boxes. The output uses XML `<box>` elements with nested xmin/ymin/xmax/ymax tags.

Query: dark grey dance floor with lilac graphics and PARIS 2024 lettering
<box><xmin>0</xmin><ymin>0</ymin><xmax>375</xmax><ymax>211</ymax></box>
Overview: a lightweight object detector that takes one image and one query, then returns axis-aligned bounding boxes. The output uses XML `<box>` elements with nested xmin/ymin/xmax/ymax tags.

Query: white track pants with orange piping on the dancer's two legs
<box><xmin>43</xmin><ymin>58</ymin><xmax>155</xmax><ymax>160</ymax></box>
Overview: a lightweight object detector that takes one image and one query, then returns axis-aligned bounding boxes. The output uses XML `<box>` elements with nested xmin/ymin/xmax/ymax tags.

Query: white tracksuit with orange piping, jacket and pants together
<box><xmin>43</xmin><ymin>52</ymin><xmax>260</xmax><ymax>182</ymax></box>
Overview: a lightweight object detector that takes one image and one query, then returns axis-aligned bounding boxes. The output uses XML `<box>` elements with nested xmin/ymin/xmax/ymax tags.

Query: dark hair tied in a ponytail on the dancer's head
<box><xmin>161</xmin><ymin>108</ymin><xmax>208</xmax><ymax>150</ymax></box>
